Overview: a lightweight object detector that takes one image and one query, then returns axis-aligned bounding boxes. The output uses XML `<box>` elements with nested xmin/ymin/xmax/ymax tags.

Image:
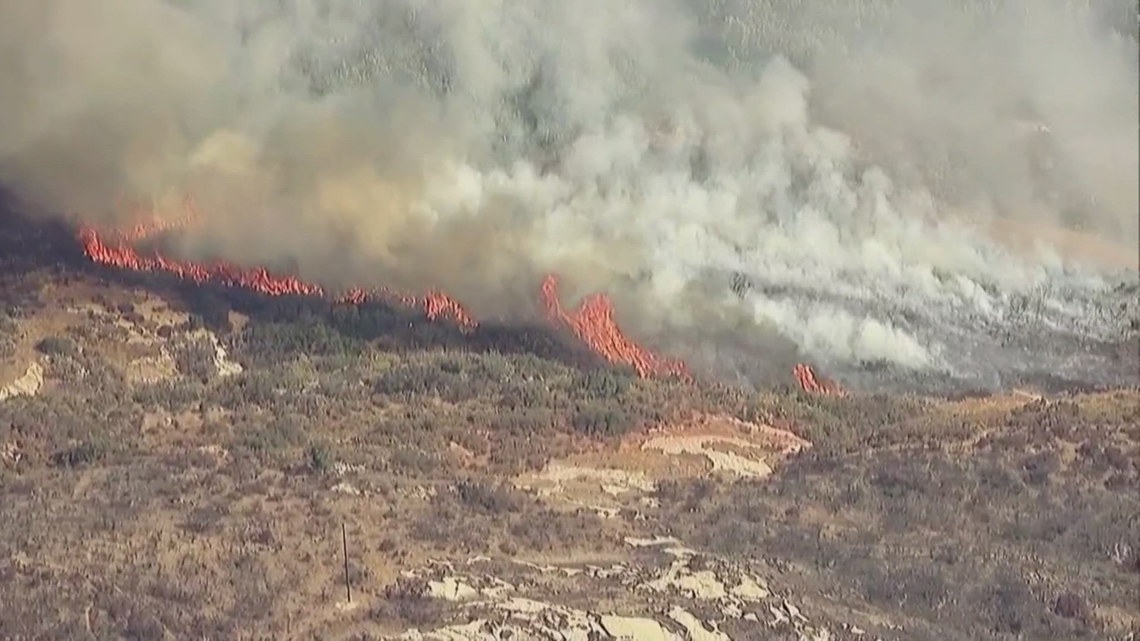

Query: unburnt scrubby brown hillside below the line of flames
<box><xmin>0</xmin><ymin>214</ymin><xmax>1140</xmax><ymax>641</ymax></box>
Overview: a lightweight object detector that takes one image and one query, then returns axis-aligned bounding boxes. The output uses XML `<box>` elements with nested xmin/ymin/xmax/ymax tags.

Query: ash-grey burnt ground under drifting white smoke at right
<box><xmin>710</xmin><ymin>264</ymin><xmax>1140</xmax><ymax>395</ymax></box>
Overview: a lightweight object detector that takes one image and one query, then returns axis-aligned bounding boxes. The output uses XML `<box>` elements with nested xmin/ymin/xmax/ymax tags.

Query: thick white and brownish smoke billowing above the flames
<box><xmin>0</xmin><ymin>0</ymin><xmax>1140</xmax><ymax>386</ymax></box>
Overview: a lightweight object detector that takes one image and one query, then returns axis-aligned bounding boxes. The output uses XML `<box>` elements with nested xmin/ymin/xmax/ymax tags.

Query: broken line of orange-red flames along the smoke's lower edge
<box><xmin>79</xmin><ymin>209</ymin><xmax>844</xmax><ymax>395</ymax></box>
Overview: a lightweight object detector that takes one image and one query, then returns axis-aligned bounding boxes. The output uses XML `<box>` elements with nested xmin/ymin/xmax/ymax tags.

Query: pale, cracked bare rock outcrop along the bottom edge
<box><xmin>391</xmin><ymin>538</ymin><xmax>858</xmax><ymax>641</ymax></box>
